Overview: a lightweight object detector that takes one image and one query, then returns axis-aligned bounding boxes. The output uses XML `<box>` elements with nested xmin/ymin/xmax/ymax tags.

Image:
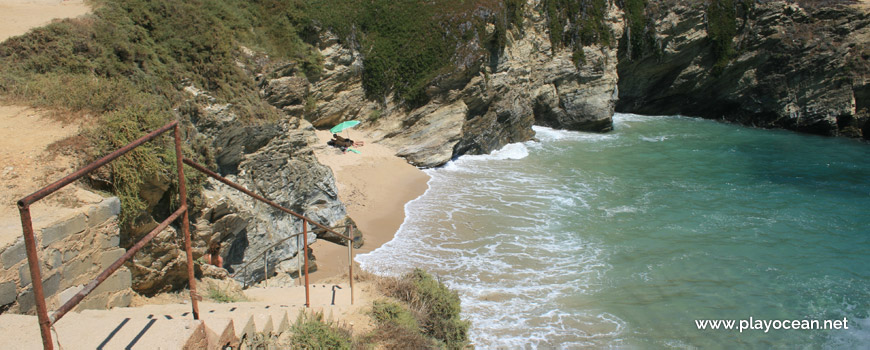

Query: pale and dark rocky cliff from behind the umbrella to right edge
<box><xmin>261</xmin><ymin>0</ymin><xmax>870</xmax><ymax>171</ymax></box>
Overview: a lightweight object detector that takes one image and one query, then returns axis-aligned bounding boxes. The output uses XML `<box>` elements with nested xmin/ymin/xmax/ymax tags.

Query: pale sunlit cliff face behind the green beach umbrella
<box><xmin>262</xmin><ymin>0</ymin><xmax>622</xmax><ymax>167</ymax></box>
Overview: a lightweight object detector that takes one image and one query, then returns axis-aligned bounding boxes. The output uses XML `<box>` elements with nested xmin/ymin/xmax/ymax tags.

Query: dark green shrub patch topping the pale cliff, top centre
<box><xmin>304</xmin><ymin>0</ymin><xmax>510</xmax><ymax>107</ymax></box>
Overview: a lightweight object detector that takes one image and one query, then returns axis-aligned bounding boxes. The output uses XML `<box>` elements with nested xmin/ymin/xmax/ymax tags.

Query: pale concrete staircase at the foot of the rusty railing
<box><xmin>0</xmin><ymin>284</ymin><xmax>359</xmax><ymax>350</ymax></box>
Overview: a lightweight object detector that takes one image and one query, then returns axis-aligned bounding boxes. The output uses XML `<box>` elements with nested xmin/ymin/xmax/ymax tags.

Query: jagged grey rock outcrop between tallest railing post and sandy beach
<box><xmin>195</xmin><ymin>113</ymin><xmax>361</xmax><ymax>282</ymax></box>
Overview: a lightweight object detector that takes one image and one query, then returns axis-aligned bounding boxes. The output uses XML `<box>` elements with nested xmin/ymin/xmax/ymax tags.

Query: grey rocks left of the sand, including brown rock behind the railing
<box><xmin>122</xmin><ymin>87</ymin><xmax>363</xmax><ymax>295</ymax></box>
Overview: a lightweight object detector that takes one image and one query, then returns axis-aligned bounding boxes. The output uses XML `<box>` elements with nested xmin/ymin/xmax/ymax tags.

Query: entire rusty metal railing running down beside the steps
<box><xmin>18</xmin><ymin>121</ymin><xmax>353</xmax><ymax>350</ymax></box>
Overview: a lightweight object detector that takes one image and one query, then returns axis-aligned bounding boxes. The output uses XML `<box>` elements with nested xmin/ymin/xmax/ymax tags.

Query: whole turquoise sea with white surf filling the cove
<box><xmin>357</xmin><ymin>114</ymin><xmax>870</xmax><ymax>349</ymax></box>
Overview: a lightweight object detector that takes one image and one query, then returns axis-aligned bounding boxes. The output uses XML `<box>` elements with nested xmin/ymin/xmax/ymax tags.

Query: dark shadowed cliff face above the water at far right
<box><xmin>617</xmin><ymin>1</ymin><xmax>870</xmax><ymax>138</ymax></box>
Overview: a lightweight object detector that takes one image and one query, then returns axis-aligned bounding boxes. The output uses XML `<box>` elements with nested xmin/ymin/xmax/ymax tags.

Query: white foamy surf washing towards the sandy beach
<box><xmin>356</xmin><ymin>150</ymin><xmax>624</xmax><ymax>349</ymax></box>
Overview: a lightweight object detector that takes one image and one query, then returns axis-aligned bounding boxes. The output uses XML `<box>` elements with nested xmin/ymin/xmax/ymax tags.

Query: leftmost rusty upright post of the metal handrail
<box><xmin>18</xmin><ymin>203</ymin><xmax>54</xmax><ymax>350</ymax></box>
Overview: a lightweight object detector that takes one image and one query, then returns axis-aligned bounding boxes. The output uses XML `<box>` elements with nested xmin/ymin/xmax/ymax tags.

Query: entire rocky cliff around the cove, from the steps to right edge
<box><xmin>117</xmin><ymin>0</ymin><xmax>870</xmax><ymax>291</ymax></box>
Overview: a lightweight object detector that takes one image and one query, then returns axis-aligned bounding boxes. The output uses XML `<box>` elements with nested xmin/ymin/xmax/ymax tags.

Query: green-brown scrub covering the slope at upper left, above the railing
<box><xmin>0</xmin><ymin>0</ymin><xmax>321</xmax><ymax>226</ymax></box>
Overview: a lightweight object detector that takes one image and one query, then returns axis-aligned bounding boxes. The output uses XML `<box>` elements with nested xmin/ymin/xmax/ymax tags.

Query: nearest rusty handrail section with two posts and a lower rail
<box><xmin>17</xmin><ymin>121</ymin><xmax>199</xmax><ymax>349</ymax></box>
